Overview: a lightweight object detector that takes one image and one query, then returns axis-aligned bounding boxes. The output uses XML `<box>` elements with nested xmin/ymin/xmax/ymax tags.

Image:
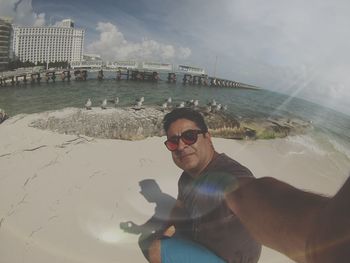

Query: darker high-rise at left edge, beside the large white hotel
<box><xmin>0</xmin><ymin>18</ymin><xmax>12</xmax><ymax>71</ymax></box>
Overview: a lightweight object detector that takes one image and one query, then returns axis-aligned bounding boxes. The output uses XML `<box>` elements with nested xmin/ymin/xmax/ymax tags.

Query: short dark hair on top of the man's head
<box><xmin>163</xmin><ymin>108</ymin><xmax>208</xmax><ymax>133</ymax></box>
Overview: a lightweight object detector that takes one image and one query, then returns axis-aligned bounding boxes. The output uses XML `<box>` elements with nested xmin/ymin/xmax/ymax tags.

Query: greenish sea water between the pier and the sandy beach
<box><xmin>0</xmin><ymin>73</ymin><xmax>350</xmax><ymax>170</ymax></box>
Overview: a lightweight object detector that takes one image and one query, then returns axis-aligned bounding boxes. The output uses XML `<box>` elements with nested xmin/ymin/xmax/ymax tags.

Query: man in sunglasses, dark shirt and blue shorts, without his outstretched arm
<box><xmin>149</xmin><ymin>108</ymin><xmax>261</xmax><ymax>263</ymax></box>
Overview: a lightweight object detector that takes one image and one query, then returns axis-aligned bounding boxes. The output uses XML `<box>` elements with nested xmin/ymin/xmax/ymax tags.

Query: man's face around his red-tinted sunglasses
<box><xmin>167</xmin><ymin>119</ymin><xmax>214</xmax><ymax>177</ymax></box>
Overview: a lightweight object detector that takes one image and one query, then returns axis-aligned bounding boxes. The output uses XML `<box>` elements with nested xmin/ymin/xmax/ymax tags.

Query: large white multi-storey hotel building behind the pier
<box><xmin>13</xmin><ymin>19</ymin><xmax>85</xmax><ymax>63</ymax></box>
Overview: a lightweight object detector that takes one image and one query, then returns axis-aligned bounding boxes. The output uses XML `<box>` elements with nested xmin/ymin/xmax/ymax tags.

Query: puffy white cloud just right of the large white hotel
<box><xmin>87</xmin><ymin>22</ymin><xmax>191</xmax><ymax>61</ymax></box>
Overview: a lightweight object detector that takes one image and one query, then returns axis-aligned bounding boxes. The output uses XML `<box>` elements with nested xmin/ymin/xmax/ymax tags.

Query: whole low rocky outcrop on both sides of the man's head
<box><xmin>30</xmin><ymin>107</ymin><xmax>311</xmax><ymax>140</ymax></box>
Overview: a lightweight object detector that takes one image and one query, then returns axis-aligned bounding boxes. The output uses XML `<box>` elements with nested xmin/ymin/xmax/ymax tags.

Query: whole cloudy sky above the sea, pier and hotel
<box><xmin>0</xmin><ymin>0</ymin><xmax>350</xmax><ymax>115</ymax></box>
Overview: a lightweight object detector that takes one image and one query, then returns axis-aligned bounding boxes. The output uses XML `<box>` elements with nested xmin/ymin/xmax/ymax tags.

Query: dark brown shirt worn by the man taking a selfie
<box><xmin>178</xmin><ymin>154</ymin><xmax>261</xmax><ymax>263</ymax></box>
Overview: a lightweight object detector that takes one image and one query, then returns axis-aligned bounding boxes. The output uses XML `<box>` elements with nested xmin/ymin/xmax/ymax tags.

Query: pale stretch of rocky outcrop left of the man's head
<box><xmin>31</xmin><ymin>108</ymin><xmax>164</xmax><ymax>140</ymax></box>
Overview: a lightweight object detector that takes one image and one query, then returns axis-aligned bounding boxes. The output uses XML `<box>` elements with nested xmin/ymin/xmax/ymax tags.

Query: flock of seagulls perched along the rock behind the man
<box><xmin>85</xmin><ymin>97</ymin><xmax>227</xmax><ymax>113</ymax></box>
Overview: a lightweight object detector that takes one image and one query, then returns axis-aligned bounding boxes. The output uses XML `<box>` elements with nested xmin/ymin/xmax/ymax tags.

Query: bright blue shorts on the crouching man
<box><xmin>160</xmin><ymin>237</ymin><xmax>225</xmax><ymax>263</ymax></box>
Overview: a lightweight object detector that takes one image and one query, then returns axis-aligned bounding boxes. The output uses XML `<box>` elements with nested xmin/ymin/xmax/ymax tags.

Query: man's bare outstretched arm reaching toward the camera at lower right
<box><xmin>226</xmin><ymin>177</ymin><xmax>330</xmax><ymax>263</ymax></box>
